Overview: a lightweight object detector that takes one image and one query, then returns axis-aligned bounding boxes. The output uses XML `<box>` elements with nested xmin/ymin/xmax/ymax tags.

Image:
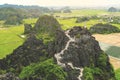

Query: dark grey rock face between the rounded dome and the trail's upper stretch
<box><xmin>47</xmin><ymin>30</ymin><xmax>68</xmax><ymax>57</ymax></box>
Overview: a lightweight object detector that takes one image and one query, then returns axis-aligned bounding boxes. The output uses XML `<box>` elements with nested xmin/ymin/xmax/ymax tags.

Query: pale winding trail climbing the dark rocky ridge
<box><xmin>55</xmin><ymin>30</ymin><xmax>84</xmax><ymax>80</ymax></box>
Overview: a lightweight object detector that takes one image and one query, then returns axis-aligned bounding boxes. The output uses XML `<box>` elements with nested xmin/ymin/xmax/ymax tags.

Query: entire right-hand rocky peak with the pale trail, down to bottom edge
<box><xmin>54</xmin><ymin>27</ymin><xmax>115</xmax><ymax>80</ymax></box>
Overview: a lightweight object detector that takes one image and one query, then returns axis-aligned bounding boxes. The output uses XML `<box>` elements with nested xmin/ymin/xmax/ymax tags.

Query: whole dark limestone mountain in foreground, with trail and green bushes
<box><xmin>0</xmin><ymin>15</ymin><xmax>116</xmax><ymax>80</ymax></box>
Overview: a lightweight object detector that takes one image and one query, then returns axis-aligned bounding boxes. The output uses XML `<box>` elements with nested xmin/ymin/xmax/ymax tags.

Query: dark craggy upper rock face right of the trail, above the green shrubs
<box><xmin>54</xmin><ymin>27</ymin><xmax>102</xmax><ymax>67</ymax></box>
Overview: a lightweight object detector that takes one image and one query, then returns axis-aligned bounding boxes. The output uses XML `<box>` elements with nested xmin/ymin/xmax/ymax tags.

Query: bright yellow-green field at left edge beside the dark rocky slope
<box><xmin>0</xmin><ymin>25</ymin><xmax>24</xmax><ymax>58</ymax></box>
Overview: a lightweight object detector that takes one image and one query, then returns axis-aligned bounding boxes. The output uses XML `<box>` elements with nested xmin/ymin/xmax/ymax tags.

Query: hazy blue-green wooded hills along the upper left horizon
<box><xmin>0</xmin><ymin>4</ymin><xmax>50</xmax><ymax>20</ymax></box>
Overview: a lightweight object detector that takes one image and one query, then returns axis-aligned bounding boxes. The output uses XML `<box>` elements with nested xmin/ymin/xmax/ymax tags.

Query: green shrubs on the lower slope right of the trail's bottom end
<box><xmin>83</xmin><ymin>53</ymin><xmax>114</xmax><ymax>80</ymax></box>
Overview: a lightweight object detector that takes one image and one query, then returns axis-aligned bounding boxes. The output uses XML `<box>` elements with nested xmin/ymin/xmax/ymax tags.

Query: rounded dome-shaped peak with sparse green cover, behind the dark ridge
<box><xmin>33</xmin><ymin>15</ymin><xmax>61</xmax><ymax>36</ymax></box>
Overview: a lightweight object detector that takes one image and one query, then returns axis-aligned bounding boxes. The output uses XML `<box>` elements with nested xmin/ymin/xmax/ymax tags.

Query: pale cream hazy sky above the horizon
<box><xmin>0</xmin><ymin>0</ymin><xmax>120</xmax><ymax>6</ymax></box>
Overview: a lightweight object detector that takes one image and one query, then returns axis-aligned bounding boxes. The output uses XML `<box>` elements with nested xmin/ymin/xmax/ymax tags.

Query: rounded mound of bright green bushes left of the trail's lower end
<box><xmin>19</xmin><ymin>59</ymin><xmax>67</xmax><ymax>80</ymax></box>
